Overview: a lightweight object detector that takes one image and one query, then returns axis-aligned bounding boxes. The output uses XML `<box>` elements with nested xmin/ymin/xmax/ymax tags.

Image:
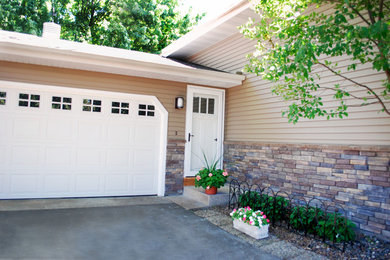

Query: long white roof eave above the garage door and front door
<box><xmin>0</xmin><ymin>41</ymin><xmax>245</xmax><ymax>88</ymax></box>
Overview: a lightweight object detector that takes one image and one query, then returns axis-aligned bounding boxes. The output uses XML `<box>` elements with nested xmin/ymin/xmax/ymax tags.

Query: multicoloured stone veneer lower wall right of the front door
<box><xmin>224</xmin><ymin>142</ymin><xmax>390</xmax><ymax>240</ymax></box>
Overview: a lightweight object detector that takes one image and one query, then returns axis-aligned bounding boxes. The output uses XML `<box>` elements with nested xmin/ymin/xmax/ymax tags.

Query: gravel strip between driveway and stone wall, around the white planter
<box><xmin>194</xmin><ymin>207</ymin><xmax>390</xmax><ymax>260</ymax></box>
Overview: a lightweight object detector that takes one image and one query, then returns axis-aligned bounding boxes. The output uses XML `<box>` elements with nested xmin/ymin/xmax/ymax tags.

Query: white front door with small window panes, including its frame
<box><xmin>184</xmin><ymin>86</ymin><xmax>224</xmax><ymax>176</ymax></box>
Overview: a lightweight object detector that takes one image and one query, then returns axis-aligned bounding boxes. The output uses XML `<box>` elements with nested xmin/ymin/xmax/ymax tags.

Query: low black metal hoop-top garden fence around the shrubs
<box><xmin>229</xmin><ymin>179</ymin><xmax>355</xmax><ymax>252</ymax></box>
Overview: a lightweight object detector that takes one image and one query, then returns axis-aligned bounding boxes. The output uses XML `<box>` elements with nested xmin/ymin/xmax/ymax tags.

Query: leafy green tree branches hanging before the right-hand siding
<box><xmin>241</xmin><ymin>0</ymin><xmax>390</xmax><ymax>123</ymax></box>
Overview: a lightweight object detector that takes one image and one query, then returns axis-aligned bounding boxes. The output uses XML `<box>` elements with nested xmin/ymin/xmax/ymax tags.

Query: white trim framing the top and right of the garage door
<box><xmin>0</xmin><ymin>80</ymin><xmax>169</xmax><ymax>196</ymax></box>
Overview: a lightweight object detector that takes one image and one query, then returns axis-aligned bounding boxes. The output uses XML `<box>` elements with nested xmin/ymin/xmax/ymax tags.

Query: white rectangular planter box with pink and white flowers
<box><xmin>230</xmin><ymin>207</ymin><xmax>269</xmax><ymax>239</ymax></box>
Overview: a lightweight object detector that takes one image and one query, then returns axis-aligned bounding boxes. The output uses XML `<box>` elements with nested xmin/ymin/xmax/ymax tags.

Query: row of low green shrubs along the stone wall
<box><xmin>239</xmin><ymin>191</ymin><xmax>355</xmax><ymax>242</ymax></box>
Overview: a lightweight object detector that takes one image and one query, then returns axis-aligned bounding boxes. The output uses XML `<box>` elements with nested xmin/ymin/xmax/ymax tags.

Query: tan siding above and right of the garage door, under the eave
<box><xmin>0</xmin><ymin>61</ymin><xmax>187</xmax><ymax>139</ymax></box>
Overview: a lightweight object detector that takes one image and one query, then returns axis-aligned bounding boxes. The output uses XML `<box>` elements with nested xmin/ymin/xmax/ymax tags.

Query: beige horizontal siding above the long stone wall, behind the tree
<box><xmin>190</xmin><ymin>16</ymin><xmax>390</xmax><ymax>145</ymax></box>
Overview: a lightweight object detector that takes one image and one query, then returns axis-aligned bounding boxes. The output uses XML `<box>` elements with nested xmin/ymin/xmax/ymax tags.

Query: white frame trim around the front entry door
<box><xmin>184</xmin><ymin>85</ymin><xmax>225</xmax><ymax>177</ymax></box>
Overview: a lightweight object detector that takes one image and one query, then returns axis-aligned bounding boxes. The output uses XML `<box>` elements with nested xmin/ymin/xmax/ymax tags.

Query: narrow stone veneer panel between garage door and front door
<box><xmin>165</xmin><ymin>139</ymin><xmax>185</xmax><ymax>195</ymax></box>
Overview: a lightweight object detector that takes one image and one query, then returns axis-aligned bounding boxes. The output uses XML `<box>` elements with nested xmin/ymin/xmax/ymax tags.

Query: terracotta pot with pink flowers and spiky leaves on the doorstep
<box><xmin>195</xmin><ymin>154</ymin><xmax>229</xmax><ymax>195</ymax></box>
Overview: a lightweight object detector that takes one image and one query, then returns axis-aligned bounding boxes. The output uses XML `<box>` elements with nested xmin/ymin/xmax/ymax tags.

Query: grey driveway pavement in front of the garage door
<box><xmin>0</xmin><ymin>198</ymin><xmax>277</xmax><ymax>260</ymax></box>
